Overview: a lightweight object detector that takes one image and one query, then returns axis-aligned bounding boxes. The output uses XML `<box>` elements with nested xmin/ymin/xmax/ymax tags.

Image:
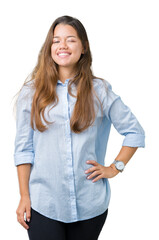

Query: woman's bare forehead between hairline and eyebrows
<box><xmin>53</xmin><ymin>23</ymin><xmax>77</xmax><ymax>37</ymax></box>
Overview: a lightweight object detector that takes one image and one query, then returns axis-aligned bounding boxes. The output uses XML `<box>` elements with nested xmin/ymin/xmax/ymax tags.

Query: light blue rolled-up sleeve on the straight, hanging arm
<box><xmin>14</xmin><ymin>86</ymin><xmax>34</xmax><ymax>166</ymax></box>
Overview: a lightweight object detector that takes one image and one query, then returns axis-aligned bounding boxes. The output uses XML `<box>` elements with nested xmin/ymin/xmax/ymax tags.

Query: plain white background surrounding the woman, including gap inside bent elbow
<box><xmin>0</xmin><ymin>0</ymin><xmax>159</xmax><ymax>240</ymax></box>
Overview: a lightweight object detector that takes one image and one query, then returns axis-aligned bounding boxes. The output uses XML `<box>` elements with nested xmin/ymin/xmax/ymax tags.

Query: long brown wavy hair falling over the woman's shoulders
<box><xmin>13</xmin><ymin>15</ymin><xmax>103</xmax><ymax>133</ymax></box>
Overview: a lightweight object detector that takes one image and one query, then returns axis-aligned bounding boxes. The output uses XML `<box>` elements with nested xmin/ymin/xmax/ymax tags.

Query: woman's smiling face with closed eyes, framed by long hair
<box><xmin>51</xmin><ymin>23</ymin><xmax>84</xmax><ymax>70</ymax></box>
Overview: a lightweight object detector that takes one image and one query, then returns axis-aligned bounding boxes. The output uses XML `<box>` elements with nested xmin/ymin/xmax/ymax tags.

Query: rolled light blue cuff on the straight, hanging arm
<box><xmin>14</xmin><ymin>152</ymin><xmax>34</xmax><ymax>166</ymax></box>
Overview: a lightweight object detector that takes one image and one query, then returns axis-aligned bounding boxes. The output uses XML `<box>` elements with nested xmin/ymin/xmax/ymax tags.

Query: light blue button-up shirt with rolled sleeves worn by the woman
<box><xmin>14</xmin><ymin>78</ymin><xmax>145</xmax><ymax>223</ymax></box>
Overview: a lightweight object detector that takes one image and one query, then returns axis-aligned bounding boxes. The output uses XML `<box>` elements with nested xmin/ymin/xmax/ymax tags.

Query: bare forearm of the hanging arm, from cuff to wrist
<box><xmin>17</xmin><ymin>164</ymin><xmax>31</xmax><ymax>197</ymax></box>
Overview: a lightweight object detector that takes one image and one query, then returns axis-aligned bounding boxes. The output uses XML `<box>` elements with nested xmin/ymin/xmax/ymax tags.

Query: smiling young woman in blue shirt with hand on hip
<box><xmin>14</xmin><ymin>16</ymin><xmax>145</xmax><ymax>240</ymax></box>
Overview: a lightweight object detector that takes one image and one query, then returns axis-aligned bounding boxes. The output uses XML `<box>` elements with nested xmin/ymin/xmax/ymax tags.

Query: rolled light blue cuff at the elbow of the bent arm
<box><xmin>122</xmin><ymin>133</ymin><xmax>145</xmax><ymax>148</ymax></box>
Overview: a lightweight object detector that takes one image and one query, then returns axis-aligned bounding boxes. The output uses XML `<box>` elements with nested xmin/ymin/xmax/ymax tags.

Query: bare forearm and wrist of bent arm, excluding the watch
<box><xmin>111</xmin><ymin>146</ymin><xmax>138</xmax><ymax>172</ymax></box>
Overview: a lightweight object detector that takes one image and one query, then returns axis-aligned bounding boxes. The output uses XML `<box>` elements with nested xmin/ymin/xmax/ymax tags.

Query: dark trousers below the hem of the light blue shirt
<box><xmin>26</xmin><ymin>208</ymin><xmax>108</xmax><ymax>240</ymax></box>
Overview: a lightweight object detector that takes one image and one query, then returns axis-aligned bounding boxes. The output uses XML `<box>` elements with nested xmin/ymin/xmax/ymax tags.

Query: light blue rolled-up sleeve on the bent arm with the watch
<box><xmin>103</xmin><ymin>80</ymin><xmax>145</xmax><ymax>148</ymax></box>
